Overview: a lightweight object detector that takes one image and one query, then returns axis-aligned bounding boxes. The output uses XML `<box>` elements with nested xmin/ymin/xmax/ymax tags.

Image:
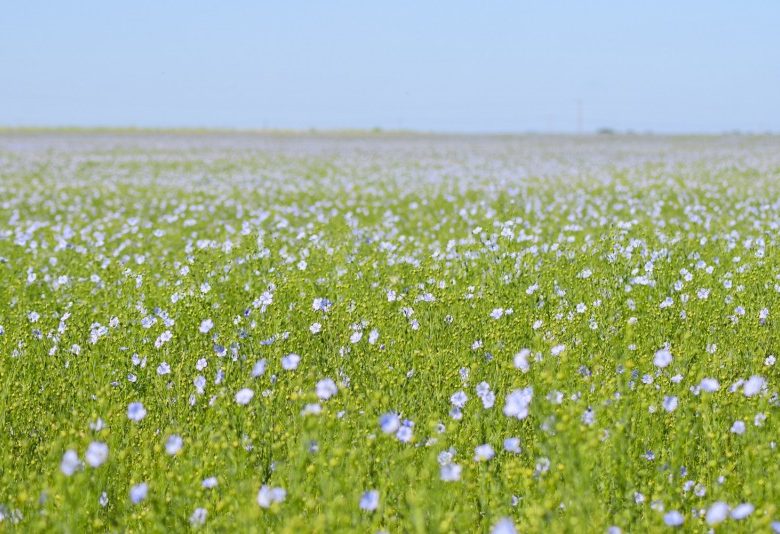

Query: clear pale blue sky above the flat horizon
<box><xmin>0</xmin><ymin>0</ymin><xmax>780</xmax><ymax>133</ymax></box>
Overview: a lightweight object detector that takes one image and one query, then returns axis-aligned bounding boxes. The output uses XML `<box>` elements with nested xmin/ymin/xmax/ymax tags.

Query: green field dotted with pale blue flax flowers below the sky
<box><xmin>0</xmin><ymin>131</ymin><xmax>780</xmax><ymax>533</ymax></box>
